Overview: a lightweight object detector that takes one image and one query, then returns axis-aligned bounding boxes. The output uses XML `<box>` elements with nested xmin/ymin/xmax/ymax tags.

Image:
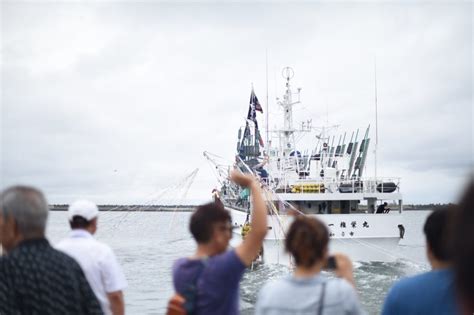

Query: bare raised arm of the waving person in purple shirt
<box><xmin>231</xmin><ymin>171</ymin><xmax>267</xmax><ymax>266</ymax></box>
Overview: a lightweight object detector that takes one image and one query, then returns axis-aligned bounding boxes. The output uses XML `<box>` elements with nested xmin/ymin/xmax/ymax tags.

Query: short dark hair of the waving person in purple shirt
<box><xmin>189</xmin><ymin>202</ymin><xmax>232</xmax><ymax>244</ymax></box>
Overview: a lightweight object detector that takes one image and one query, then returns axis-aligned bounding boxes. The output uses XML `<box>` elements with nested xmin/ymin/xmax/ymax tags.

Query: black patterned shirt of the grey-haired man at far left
<box><xmin>0</xmin><ymin>239</ymin><xmax>103</xmax><ymax>315</ymax></box>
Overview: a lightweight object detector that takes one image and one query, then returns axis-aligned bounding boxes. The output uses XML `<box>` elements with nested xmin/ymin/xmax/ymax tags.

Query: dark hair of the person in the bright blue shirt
<box><xmin>423</xmin><ymin>206</ymin><xmax>456</xmax><ymax>262</ymax></box>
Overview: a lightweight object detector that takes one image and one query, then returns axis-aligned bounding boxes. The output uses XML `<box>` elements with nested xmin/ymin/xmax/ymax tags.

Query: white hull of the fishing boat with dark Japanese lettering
<box><xmin>227</xmin><ymin>207</ymin><xmax>403</xmax><ymax>266</ymax></box>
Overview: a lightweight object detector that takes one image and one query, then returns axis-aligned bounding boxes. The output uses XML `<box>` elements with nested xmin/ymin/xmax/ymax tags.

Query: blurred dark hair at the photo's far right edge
<box><xmin>453</xmin><ymin>179</ymin><xmax>474</xmax><ymax>314</ymax></box>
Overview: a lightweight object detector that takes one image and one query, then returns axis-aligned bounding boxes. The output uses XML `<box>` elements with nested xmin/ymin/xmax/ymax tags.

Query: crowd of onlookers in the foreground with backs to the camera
<box><xmin>0</xmin><ymin>172</ymin><xmax>474</xmax><ymax>315</ymax></box>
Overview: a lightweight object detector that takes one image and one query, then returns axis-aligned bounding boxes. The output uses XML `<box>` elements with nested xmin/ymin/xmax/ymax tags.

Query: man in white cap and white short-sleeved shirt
<box><xmin>56</xmin><ymin>200</ymin><xmax>127</xmax><ymax>315</ymax></box>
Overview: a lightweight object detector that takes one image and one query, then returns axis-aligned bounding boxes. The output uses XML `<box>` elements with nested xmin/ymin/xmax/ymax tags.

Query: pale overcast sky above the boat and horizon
<box><xmin>0</xmin><ymin>1</ymin><xmax>474</xmax><ymax>203</ymax></box>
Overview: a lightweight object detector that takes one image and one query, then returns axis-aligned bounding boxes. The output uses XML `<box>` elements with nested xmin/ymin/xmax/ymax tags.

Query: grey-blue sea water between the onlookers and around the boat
<box><xmin>47</xmin><ymin>211</ymin><xmax>429</xmax><ymax>314</ymax></box>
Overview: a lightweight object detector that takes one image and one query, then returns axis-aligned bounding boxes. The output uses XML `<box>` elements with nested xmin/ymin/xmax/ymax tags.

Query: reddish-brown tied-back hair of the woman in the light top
<box><xmin>285</xmin><ymin>216</ymin><xmax>329</xmax><ymax>267</ymax></box>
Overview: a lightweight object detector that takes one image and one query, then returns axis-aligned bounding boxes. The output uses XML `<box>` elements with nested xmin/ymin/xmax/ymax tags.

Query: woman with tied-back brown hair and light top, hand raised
<box><xmin>255</xmin><ymin>216</ymin><xmax>364</xmax><ymax>315</ymax></box>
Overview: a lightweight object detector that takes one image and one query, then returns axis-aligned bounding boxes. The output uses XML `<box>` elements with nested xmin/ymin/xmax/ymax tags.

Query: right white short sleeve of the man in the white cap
<box><xmin>101</xmin><ymin>247</ymin><xmax>127</xmax><ymax>293</ymax></box>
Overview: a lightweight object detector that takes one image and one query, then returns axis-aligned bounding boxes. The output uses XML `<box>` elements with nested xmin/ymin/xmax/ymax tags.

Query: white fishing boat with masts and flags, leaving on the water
<box><xmin>204</xmin><ymin>67</ymin><xmax>405</xmax><ymax>264</ymax></box>
